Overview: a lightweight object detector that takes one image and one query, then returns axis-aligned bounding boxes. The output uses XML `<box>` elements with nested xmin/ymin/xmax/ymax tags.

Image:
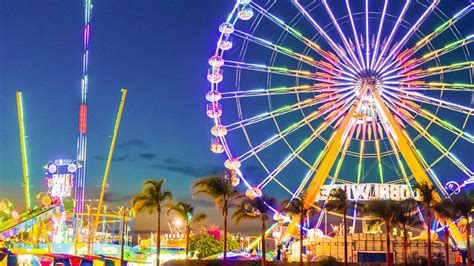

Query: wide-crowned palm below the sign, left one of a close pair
<box><xmin>365</xmin><ymin>200</ymin><xmax>399</xmax><ymax>266</ymax></box>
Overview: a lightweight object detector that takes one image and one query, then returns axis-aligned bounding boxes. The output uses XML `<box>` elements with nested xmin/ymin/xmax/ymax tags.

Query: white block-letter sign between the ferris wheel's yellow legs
<box><xmin>316</xmin><ymin>183</ymin><xmax>418</xmax><ymax>201</ymax></box>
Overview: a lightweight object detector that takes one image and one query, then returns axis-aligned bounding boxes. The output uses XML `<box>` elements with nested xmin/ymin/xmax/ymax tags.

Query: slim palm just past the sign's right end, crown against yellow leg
<box><xmin>413</xmin><ymin>183</ymin><xmax>436</xmax><ymax>266</ymax></box>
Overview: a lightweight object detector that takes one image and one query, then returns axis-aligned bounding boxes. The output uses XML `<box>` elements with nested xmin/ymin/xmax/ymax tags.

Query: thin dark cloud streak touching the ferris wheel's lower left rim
<box><xmin>148</xmin><ymin>158</ymin><xmax>223</xmax><ymax>177</ymax></box>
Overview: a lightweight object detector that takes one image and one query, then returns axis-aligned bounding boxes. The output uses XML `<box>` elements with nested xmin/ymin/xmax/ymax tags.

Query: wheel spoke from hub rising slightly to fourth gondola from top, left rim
<box><xmin>224</xmin><ymin>60</ymin><xmax>346</xmax><ymax>84</ymax></box>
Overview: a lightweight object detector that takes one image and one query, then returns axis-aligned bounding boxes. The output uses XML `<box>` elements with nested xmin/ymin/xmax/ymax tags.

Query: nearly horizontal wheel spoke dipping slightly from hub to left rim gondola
<box><xmin>221</xmin><ymin>82</ymin><xmax>353</xmax><ymax>100</ymax></box>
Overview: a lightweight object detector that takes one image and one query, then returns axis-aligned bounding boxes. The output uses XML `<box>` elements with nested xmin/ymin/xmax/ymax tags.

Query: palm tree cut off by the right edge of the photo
<box><xmin>451</xmin><ymin>190</ymin><xmax>474</xmax><ymax>265</ymax></box>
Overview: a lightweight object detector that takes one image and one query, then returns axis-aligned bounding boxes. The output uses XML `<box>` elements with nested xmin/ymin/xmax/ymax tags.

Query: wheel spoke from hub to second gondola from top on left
<box><xmin>234</xmin><ymin>30</ymin><xmax>353</xmax><ymax>81</ymax></box>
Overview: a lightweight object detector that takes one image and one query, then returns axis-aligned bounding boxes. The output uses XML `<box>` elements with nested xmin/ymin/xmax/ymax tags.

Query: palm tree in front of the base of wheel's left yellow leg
<box><xmin>281</xmin><ymin>192</ymin><xmax>316</xmax><ymax>265</ymax></box>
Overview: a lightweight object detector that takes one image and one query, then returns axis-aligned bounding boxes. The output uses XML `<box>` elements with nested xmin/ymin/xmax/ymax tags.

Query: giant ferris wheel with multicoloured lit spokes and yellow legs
<box><xmin>206</xmin><ymin>0</ymin><xmax>474</xmax><ymax>224</ymax></box>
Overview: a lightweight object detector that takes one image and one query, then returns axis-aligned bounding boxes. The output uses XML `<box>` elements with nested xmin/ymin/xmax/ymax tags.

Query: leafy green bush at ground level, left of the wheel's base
<box><xmin>189</xmin><ymin>232</ymin><xmax>239</xmax><ymax>259</ymax></box>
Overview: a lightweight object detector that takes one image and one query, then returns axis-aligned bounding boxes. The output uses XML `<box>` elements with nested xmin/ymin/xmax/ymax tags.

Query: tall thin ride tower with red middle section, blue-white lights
<box><xmin>74</xmin><ymin>0</ymin><xmax>92</xmax><ymax>214</ymax></box>
